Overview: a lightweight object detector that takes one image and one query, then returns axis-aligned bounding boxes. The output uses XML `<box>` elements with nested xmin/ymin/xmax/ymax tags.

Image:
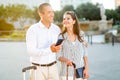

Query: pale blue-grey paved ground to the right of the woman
<box><xmin>88</xmin><ymin>44</ymin><xmax>120</xmax><ymax>80</ymax></box>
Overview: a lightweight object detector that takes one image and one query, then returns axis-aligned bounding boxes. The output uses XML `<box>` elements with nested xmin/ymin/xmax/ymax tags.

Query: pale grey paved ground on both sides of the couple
<box><xmin>0</xmin><ymin>42</ymin><xmax>120</xmax><ymax>80</ymax></box>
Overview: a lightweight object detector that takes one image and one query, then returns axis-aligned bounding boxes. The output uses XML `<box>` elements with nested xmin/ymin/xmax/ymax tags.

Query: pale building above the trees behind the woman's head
<box><xmin>60</xmin><ymin>0</ymin><xmax>91</xmax><ymax>9</ymax></box>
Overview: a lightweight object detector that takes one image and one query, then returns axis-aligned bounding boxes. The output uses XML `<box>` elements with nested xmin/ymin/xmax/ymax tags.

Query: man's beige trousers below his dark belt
<box><xmin>30</xmin><ymin>64</ymin><xmax>60</xmax><ymax>80</ymax></box>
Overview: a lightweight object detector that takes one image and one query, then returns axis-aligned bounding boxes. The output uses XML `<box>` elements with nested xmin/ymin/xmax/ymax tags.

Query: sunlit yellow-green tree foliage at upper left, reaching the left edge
<box><xmin>0</xmin><ymin>4</ymin><xmax>34</xmax><ymax>27</ymax></box>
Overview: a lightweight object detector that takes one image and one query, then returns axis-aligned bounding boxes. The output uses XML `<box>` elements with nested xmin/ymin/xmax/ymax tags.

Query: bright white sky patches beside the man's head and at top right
<box><xmin>50</xmin><ymin>0</ymin><xmax>115</xmax><ymax>10</ymax></box>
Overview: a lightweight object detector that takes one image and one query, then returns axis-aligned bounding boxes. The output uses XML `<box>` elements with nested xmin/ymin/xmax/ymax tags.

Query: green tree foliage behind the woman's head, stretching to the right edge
<box><xmin>55</xmin><ymin>3</ymin><xmax>120</xmax><ymax>22</ymax></box>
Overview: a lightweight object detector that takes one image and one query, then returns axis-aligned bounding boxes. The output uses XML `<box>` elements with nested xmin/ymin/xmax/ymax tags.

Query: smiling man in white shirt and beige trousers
<box><xmin>26</xmin><ymin>3</ymin><xmax>60</xmax><ymax>80</ymax></box>
